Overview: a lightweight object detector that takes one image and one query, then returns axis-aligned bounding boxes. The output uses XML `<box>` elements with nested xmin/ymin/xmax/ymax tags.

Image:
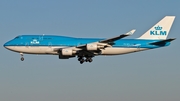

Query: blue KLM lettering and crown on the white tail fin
<box><xmin>150</xmin><ymin>26</ymin><xmax>167</xmax><ymax>35</ymax></box>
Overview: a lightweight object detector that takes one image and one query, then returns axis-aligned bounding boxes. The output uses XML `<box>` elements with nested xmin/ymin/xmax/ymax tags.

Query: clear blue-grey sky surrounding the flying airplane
<box><xmin>0</xmin><ymin>0</ymin><xmax>180</xmax><ymax>101</ymax></box>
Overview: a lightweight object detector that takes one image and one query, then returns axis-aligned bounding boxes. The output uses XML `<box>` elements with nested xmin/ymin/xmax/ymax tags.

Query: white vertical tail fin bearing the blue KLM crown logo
<box><xmin>138</xmin><ymin>16</ymin><xmax>175</xmax><ymax>39</ymax></box>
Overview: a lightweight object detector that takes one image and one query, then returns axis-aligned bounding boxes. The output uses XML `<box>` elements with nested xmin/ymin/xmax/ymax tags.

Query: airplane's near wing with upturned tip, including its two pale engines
<box><xmin>54</xmin><ymin>29</ymin><xmax>135</xmax><ymax>58</ymax></box>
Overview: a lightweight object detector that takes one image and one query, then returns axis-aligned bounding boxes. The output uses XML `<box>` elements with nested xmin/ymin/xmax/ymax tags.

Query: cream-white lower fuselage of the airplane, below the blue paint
<box><xmin>6</xmin><ymin>46</ymin><xmax>147</xmax><ymax>55</ymax></box>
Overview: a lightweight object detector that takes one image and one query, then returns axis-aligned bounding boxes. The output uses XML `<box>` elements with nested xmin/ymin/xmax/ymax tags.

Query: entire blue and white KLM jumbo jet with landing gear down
<box><xmin>4</xmin><ymin>16</ymin><xmax>175</xmax><ymax>64</ymax></box>
